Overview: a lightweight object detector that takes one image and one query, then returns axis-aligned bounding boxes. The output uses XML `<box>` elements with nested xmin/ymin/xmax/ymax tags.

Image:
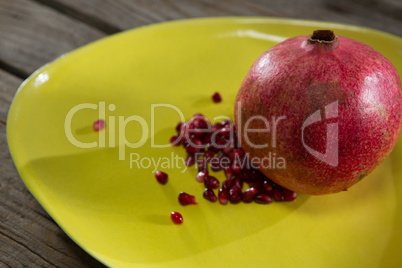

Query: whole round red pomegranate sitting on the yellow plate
<box><xmin>235</xmin><ymin>31</ymin><xmax>402</xmax><ymax>195</ymax></box>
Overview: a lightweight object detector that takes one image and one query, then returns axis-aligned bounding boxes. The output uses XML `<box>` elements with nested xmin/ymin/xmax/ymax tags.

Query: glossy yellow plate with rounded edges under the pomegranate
<box><xmin>7</xmin><ymin>18</ymin><xmax>402</xmax><ymax>268</ymax></box>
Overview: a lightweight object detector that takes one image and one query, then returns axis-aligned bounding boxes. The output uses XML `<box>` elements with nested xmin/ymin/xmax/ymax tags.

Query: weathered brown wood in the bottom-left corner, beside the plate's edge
<box><xmin>0</xmin><ymin>124</ymin><xmax>105</xmax><ymax>267</ymax></box>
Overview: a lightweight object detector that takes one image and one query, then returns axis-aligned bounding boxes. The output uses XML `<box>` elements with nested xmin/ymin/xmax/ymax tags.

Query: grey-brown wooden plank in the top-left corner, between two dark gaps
<box><xmin>0</xmin><ymin>0</ymin><xmax>105</xmax><ymax>77</ymax></box>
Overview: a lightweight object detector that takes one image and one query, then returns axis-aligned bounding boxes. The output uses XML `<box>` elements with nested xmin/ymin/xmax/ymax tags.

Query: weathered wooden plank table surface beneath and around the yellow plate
<box><xmin>0</xmin><ymin>0</ymin><xmax>402</xmax><ymax>268</ymax></box>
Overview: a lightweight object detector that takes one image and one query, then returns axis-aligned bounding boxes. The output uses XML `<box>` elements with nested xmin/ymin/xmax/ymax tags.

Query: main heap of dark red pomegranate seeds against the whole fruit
<box><xmin>170</xmin><ymin>113</ymin><xmax>297</xmax><ymax>205</ymax></box>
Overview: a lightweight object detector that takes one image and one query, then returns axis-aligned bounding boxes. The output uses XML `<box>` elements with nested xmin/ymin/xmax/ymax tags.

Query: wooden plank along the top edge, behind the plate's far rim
<box><xmin>32</xmin><ymin>0</ymin><xmax>402</xmax><ymax>36</ymax></box>
